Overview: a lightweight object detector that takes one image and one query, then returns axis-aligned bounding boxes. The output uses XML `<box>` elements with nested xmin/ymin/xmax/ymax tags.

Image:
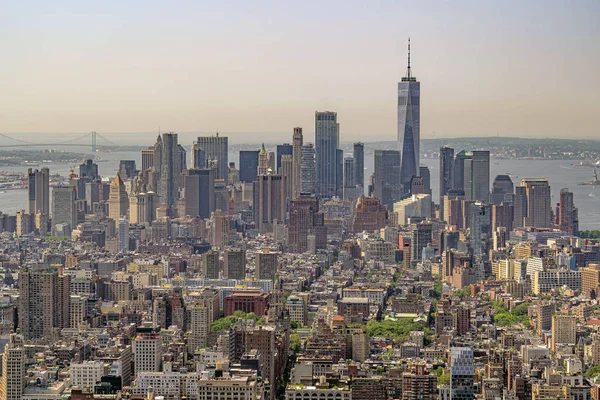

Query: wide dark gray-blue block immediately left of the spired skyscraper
<box><xmin>373</xmin><ymin>150</ymin><xmax>400</xmax><ymax>210</ymax></box>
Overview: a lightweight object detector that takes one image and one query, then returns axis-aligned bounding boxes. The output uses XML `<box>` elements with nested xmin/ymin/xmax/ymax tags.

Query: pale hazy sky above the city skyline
<box><xmin>0</xmin><ymin>0</ymin><xmax>600</xmax><ymax>141</ymax></box>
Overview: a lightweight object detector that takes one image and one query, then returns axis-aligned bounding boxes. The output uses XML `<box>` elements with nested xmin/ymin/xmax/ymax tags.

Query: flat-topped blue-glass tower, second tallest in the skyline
<box><xmin>315</xmin><ymin>111</ymin><xmax>340</xmax><ymax>198</ymax></box>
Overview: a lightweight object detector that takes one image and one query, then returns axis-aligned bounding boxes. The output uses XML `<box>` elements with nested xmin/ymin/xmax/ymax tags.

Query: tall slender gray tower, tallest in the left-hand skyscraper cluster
<box><xmin>159</xmin><ymin>133</ymin><xmax>180</xmax><ymax>209</ymax></box>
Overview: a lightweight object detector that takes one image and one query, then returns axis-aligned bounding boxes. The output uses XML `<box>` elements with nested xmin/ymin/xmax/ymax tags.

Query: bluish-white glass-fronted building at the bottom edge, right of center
<box><xmin>450</xmin><ymin>347</ymin><xmax>475</xmax><ymax>400</ymax></box>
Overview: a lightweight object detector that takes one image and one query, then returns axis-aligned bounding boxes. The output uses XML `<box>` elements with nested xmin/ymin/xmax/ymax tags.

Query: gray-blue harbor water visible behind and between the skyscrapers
<box><xmin>0</xmin><ymin>146</ymin><xmax>600</xmax><ymax>230</ymax></box>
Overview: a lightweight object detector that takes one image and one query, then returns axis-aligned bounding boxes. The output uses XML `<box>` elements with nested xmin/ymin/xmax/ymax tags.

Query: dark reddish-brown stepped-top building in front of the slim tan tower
<box><xmin>288</xmin><ymin>194</ymin><xmax>327</xmax><ymax>253</ymax></box>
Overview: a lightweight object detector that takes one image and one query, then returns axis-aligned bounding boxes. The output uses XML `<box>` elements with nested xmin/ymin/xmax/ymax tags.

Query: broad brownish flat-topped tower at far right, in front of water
<box><xmin>515</xmin><ymin>178</ymin><xmax>552</xmax><ymax>228</ymax></box>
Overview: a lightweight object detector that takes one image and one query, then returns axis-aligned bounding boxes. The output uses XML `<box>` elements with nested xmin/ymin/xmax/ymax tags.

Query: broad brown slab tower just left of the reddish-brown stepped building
<box><xmin>253</xmin><ymin>174</ymin><xmax>286</xmax><ymax>232</ymax></box>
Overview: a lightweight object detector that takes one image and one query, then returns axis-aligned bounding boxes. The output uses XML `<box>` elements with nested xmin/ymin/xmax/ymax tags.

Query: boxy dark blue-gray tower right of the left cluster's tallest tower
<box><xmin>184</xmin><ymin>168</ymin><xmax>215</xmax><ymax>218</ymax></box>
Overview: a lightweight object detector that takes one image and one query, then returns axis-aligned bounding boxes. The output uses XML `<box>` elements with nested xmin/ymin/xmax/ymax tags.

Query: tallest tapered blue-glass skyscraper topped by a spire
<box><xmin>398</xmin><ymin>39</ymin><xmax>421</xmax><ymax>191</ymax></box>
